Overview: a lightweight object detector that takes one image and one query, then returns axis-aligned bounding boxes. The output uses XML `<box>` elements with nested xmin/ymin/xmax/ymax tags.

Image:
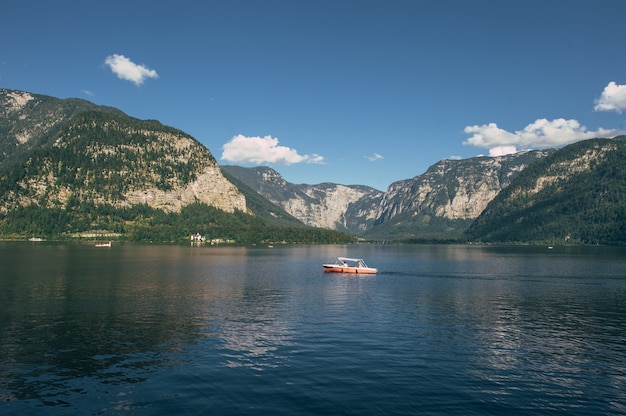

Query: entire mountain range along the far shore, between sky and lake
<box><xmin>0</xmin><ymin>89</ymin><xmax>626</xmax><ymax>244</ymax></box>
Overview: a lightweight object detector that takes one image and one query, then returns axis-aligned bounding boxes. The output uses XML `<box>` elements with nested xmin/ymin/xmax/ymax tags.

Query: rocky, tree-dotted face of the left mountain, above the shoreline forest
<box><xmin>0</xmin><ymin>90</ymin><xmax>248</xmax><ymax>212</ymax></box>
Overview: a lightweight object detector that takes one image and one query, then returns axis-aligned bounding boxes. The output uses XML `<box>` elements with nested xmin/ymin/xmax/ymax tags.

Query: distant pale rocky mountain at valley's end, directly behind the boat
<box><xmin>222</xmin><ymin>165</ymin><xmax>383</xmax><ymax>235</ymax></box>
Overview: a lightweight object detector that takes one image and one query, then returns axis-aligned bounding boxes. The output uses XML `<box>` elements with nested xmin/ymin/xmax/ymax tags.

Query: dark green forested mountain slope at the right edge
<box><xmin>465</xmin><ymin>136</ymin><xmax>626</xmax><ymax>244</ymax></box>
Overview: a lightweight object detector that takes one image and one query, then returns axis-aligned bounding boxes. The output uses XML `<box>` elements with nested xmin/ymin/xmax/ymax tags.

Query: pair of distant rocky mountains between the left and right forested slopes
<box><xmin>222</xmin><ymin>150</ymin><xmax>553</xmax><ymax>239</ymax></box>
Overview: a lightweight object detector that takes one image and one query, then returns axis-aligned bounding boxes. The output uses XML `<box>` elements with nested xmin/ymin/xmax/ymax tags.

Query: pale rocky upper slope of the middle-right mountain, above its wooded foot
<box><xmin>376</xmin><ymin>151</ymin><xmax>550</xmax><ymax>224</ymax></box>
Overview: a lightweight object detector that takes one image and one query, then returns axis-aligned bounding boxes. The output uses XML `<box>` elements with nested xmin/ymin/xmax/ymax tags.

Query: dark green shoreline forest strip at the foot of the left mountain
<box><xmin>0</xmin><ymin>200</ymin><xmax>354</xmax><ymax>244</ymax></box>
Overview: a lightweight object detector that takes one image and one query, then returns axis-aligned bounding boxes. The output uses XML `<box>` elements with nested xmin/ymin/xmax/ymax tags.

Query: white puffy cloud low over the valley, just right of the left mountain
<box><xmin>222</xmin><ymin>134</ymin><xmax>324</xmax><ymax>165</ymax></box>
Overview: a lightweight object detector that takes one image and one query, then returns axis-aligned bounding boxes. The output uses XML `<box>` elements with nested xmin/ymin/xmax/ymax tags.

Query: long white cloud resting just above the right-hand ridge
<box><xmin>463</xmin><ymin>118</ymin><xmax>623</xmax><ymax>151</ymax></box>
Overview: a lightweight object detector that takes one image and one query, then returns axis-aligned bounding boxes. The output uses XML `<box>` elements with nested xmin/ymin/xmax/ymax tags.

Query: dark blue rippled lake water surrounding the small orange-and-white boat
<box><xmin>0</xmin><ymin>243</ymin><xmax>626</xmax><ymax>415</ymax></box>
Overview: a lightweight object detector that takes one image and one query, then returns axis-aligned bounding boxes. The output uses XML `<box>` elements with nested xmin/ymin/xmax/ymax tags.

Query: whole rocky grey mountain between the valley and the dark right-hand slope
<box><xmin>366</xmin><ymin>150</ymin><xmax>554</xmax><ymax>240</ymax></box>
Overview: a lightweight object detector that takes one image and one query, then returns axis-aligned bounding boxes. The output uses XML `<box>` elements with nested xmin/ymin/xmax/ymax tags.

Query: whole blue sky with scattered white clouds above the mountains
<box><xmin>0</xmin><ymin>0</ymin><xmax>626</xmax><ymax>190</ymax></box>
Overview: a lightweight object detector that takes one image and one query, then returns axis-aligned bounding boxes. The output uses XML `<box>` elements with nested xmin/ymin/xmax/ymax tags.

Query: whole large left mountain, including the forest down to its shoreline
<box><xmin>0</xmin><ymin>89</ymin><xmax>353</xmax><ymax>243</ymax></box>
